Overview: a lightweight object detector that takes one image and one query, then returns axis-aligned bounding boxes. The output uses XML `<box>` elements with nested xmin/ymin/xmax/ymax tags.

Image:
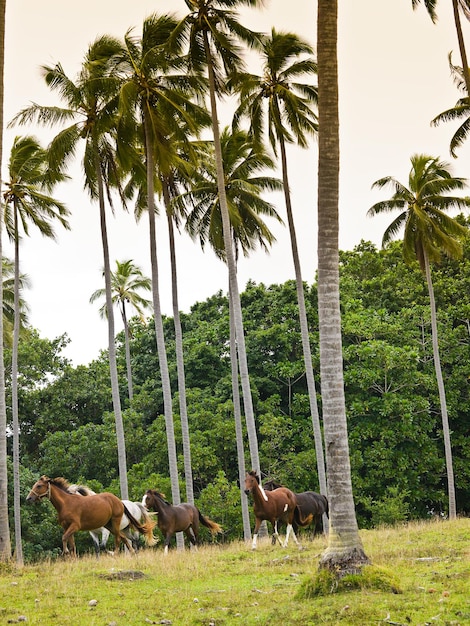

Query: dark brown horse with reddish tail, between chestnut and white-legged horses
<box><xmin>142</xmin><ymin>489</ymin><xmax>222</xmax><ymax>554</ymax></box>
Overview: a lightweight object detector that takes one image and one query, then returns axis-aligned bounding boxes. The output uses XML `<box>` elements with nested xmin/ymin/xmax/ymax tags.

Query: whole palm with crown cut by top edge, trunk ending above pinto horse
<box><xmin>173</xmin><ymin>0</ymin><xmax>262</xmax><ymax>473</ymax></box>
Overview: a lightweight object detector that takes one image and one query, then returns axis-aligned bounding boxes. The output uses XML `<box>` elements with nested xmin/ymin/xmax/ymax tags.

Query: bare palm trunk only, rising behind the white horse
<box><xmin>95</xmin><ymin>145</ymin><xmax>129</xmax><ymax>500</ymax></box>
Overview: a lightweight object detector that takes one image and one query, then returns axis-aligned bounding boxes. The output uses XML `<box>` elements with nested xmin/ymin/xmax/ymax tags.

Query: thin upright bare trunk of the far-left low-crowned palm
<box><xmin>11</xmin><ymin>207</ymin><xmax>23</xmax><ymax>565</ymax></box>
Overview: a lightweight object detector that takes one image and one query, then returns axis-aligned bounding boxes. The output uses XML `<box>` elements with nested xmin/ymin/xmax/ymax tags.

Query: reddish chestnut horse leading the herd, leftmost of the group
<box><xmin>26</xmin><ymin>476</ymin><xmax>155</xmax><ymax>557</ymax></box>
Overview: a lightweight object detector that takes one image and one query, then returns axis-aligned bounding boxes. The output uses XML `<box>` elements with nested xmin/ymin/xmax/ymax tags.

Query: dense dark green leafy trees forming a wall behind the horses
<box><xmin>6</xmin><ymin>233</ymin><xmax>470</xmax><ymax>558</ymax></box>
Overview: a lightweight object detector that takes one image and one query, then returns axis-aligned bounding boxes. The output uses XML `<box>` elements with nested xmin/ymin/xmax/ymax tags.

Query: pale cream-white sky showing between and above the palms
<box><xmin>3</xmin><ymin>0</ymin><xmax>470</xmax><ymax>365</ymax></box>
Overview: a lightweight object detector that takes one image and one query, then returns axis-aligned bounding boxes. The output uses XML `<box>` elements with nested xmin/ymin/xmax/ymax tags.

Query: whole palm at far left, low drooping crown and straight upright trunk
<box><xmin>3</xmin><ymin>136</ymin><xmax>69</xmax><ymax>564</ymax></box>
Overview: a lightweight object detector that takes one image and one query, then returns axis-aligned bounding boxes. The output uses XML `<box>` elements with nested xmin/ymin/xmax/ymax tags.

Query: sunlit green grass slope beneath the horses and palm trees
<box><xmin>0</xmin><ymin>519</ymin><xmax>470</xmax><ymax>626</ymax></box>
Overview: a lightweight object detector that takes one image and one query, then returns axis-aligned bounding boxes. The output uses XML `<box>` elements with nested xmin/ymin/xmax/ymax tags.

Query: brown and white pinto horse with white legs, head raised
<box><xmin>245</xmin><ymin>470</ymin><xmax>306</xmax><ymax>550</ymax></box>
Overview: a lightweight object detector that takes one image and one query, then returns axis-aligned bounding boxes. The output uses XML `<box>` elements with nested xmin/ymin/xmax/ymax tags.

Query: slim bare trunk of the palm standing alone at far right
<box><xmin>424</xmin><ymin>251</ymin><xmax>457</xmax><ymax>519</ymax></box>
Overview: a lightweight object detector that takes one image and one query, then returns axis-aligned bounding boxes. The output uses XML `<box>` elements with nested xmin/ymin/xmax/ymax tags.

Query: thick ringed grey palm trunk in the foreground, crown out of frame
<box><xmin>317</xmin><ymin>0</ymin><xmax>368</xmax><ymax>576</ymax></box>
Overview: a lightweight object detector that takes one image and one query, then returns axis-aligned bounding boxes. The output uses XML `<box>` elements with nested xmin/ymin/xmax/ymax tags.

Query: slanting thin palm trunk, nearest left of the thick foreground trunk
<box><xmin>279</xmin><ymin>125</ymin><xmax>328</xmax><ymax>520</ymax></box>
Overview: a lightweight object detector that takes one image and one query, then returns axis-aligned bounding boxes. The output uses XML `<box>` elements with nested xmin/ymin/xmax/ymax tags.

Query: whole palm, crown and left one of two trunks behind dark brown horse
<box><xmin>113</xmin><ymin>15</ymin><xmax>208</xmax><ymax>512</ymax></box>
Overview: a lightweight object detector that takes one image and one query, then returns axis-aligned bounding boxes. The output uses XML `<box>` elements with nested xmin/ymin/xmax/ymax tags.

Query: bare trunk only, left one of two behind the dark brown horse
<box><xmin>144</xmin><ymin>114</ymin><xmax>184</xmax><ymax>532</ymax></box>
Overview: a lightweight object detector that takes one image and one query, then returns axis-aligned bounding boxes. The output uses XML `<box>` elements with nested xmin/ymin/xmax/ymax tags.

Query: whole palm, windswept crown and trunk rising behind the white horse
<box><xmin>13</xmin><ymin>36</ymin><xmax>132</xmax><ymax>499</ymax></box>
